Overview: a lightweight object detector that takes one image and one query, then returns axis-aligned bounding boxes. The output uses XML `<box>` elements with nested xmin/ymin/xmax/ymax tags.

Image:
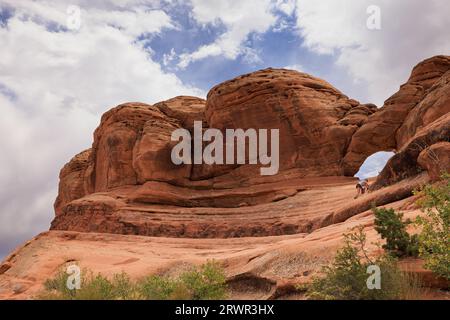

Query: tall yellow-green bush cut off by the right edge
<box><xmin>417</xmin><ymin>174</ymin><xmax>450</xmax><ymax>280</ymax></box>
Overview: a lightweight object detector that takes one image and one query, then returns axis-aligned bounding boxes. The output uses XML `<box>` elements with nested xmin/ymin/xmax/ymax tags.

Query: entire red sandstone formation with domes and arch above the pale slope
<box><xmin>51</xmin><ymin>56</ymin><xmax>450</xmax><ymax>238</ymax></box>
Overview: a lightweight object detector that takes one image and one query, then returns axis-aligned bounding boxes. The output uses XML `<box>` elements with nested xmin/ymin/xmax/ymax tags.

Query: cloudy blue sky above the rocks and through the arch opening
<box><xmin>0</xmin><ymin>0</ymin><xmax>450</xmax><ymax>258</ymax></box>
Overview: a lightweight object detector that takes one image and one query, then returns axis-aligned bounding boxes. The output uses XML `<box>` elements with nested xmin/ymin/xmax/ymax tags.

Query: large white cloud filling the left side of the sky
<box><xmin>0</xmin><ymin>1</ymin><xmax>204</xmax><ymax>255</ymax></box>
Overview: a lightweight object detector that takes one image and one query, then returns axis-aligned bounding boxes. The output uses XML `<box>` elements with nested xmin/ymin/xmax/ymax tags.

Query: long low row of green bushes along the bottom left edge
<box><xmin>37</xmin><ymin>262</ymin><xmax>226</xmax><ymax>300</ymax></box>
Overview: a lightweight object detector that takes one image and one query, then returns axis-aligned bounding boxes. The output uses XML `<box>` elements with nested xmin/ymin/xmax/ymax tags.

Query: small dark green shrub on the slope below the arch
<box><xmin>372</xmin><ymin>208</ymin><xmax>419</xmax><ymax>257</ymax></box>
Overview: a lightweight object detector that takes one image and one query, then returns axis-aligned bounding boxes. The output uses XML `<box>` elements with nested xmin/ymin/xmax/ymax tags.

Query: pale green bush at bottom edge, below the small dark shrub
<box><xmin>306</xmin><ymin>227</ymin><xmax>420</xmax><ymax>300</ymax></box>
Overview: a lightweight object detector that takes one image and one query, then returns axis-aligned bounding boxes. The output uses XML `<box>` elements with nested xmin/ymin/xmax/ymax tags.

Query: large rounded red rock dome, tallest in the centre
<box><xmin>205</xmin><ymin>69</ymin><xmax>370</xmax><ymax>176</ymax></box>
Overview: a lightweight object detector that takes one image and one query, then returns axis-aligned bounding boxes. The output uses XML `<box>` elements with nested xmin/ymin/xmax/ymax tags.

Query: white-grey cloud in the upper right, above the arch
<box><xmin>296</xmin><ymin>0</ymin><xmax>450</xmax><ymax>105</ymax></box>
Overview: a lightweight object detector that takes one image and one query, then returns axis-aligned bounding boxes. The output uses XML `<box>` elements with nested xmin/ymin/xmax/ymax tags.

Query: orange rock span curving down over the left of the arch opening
<box><xmin>344</xmin><ymin>56</ymin><xmax>450</xmax><ymax>175</ymax></box>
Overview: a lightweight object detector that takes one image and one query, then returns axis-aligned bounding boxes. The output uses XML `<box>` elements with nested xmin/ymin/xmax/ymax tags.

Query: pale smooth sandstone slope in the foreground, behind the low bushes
<box><xmin>0</xmin><ymin>189</ymin><xmax>450</xmax><ymax>299</ymax></box>
